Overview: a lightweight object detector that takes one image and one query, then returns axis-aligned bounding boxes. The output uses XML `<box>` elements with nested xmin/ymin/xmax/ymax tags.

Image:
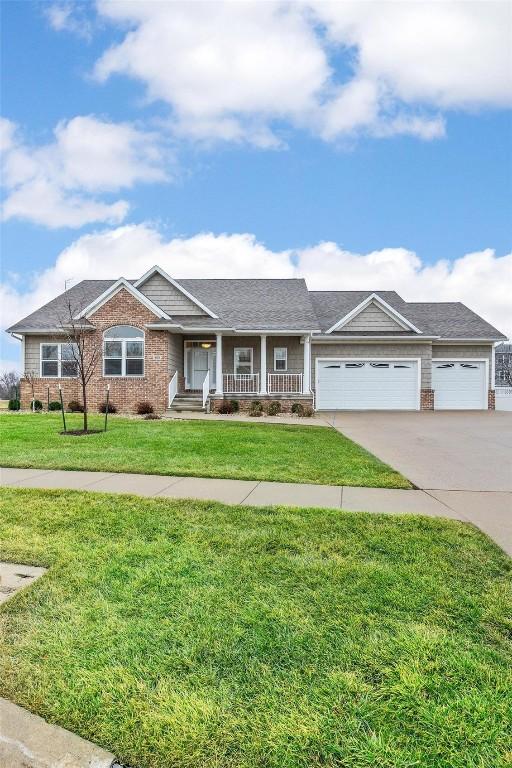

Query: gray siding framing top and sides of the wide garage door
<box><xmin>311</xmin><ymin>343</ymin><xmax>432</xmax><ymax>389</ymax></box>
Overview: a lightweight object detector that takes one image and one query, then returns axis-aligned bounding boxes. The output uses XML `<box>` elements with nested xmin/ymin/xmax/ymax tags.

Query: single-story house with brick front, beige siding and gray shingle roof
<box><xmin>8</xmin><ymin>267</ymin><xmax>505</xmax><ymax>412</ymax></box>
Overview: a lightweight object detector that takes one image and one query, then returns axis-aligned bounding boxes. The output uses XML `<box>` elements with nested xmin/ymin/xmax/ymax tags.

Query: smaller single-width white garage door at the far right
<box><xmin>432</xmin><ymin>360</ymin><xmax>487</xmax><ymax>410</ymax></box>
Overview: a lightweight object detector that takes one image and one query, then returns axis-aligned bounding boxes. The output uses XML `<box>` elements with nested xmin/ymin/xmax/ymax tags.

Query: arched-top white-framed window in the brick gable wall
<box><xmin>103</xmin><ymin>325</ymin><xmax>144</xmax><ymax>376</ymax></box>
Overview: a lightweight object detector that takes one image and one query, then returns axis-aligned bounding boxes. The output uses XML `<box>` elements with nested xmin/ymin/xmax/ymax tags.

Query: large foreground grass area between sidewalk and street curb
<box><xmin>0</xmin><ymin>489</ymin><xmax>512</xmax><ymax>768</ymax></box>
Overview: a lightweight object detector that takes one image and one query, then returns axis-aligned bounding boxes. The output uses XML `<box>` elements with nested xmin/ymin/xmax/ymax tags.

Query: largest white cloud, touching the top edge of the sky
<box><xmin>95</xmin><ymin>0</ymin><xmax>512</xmax><ymax>147</ymax></box>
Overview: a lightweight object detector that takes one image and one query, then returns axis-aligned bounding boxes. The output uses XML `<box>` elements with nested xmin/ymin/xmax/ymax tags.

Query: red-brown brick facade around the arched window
<box><xmin>20</xmin><ymin>288</ymin><xmax>170</xmax><ymax>413</ymax></box>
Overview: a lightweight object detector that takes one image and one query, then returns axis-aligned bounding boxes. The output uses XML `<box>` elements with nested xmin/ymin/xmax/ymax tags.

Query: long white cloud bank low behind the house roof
<box><xmin>0</xmin><ymin>224</ymin><xmax>512</xmax><ymax>368</ymax></box>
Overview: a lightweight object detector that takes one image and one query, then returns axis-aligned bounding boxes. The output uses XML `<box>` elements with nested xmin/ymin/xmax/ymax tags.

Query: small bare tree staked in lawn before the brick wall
<box><xmin>59</xmin><ymin>298</ymin><xmax>102</xmax><ymax>432</ymax></box>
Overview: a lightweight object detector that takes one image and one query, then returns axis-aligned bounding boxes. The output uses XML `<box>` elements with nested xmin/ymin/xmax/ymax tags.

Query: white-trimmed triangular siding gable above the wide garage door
<box><xmin>327</xmin><ymin>293</ymin><xmax>421</xmax><ymax>333</ymax></box>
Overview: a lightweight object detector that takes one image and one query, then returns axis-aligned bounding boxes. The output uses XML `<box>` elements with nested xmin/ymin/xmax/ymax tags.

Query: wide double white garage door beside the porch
<box><xmin>316</xmin><ymin>360</ymin><xmax>419</xmax><ymax>411</ymax></box>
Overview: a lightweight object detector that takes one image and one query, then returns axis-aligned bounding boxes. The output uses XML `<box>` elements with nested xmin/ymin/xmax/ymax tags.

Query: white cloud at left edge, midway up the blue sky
<box><xmin>0</xmin><ymin>115</ymin><xmax>166</xmax><ymax>227</ymax></box>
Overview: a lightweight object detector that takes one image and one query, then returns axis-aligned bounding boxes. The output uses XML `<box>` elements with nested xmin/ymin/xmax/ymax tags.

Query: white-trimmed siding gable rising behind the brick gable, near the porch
<box><xmin>135</xmin><ymin>266</ymin><xmax>217</xmax><ymax>318</ymax></box>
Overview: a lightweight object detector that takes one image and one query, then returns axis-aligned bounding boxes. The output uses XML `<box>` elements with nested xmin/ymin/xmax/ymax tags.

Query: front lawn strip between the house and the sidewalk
<box><xmin>0</xmin><ymin>414</ymin><xmax>411</xmax><ymax>488</ymax></box>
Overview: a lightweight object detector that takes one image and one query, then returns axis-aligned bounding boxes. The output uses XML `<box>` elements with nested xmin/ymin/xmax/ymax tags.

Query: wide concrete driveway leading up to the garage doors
<box><xmin>322</xmin><ymin>411</ymin><xmax>512</xmax><ymax>555</ymax></box>
